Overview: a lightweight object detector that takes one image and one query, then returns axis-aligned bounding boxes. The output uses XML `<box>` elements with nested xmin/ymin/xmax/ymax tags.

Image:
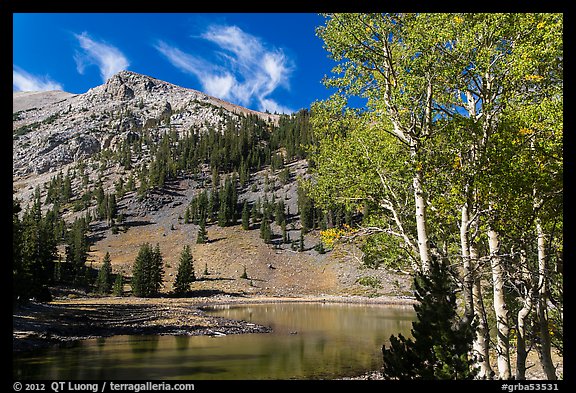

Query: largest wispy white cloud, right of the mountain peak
<box><xmin>155</xmin><ymin>25</ymin><xmax>293</xmax><ymax>113</ymax></box>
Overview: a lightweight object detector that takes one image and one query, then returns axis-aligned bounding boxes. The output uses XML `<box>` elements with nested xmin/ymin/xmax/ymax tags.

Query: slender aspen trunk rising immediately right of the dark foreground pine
<box><xmin>470</xmin><ymin>244</ymin><xmax>494</xmax><ymax>379</ymax></box>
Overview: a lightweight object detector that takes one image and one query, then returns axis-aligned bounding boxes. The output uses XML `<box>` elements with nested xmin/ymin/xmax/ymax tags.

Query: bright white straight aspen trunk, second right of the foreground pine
<box><xmin>488</xmin><ymin>227</ymin><xmax>512</xmax><ymax>379</ymax></box>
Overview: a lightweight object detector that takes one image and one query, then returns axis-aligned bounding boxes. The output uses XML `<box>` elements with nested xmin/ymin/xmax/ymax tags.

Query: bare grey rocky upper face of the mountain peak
<box><xmin>12</xmin><ymin>71</ymin><xmax>278</xmax><ymax>178</ymax></box>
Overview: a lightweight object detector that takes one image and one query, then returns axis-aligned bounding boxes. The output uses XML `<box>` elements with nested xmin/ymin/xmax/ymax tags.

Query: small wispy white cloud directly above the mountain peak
<box><xmin>74</xmin><ymin>32</ymin><xmax>130</xmax><ymax>82</ymax></box>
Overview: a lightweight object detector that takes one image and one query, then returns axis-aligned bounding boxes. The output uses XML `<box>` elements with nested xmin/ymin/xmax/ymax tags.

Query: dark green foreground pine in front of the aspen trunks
<box><xmin>382</xmin><ymin>261</ymin><xmax>477</xmax><ymax>379</ymax></box>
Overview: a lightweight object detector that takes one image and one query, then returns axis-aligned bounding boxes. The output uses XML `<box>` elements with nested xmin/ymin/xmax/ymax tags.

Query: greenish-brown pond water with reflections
<box><xmin>13</xmin><ymin>303</ymin><xmax>415</xmax><ymax>380</ymax></box>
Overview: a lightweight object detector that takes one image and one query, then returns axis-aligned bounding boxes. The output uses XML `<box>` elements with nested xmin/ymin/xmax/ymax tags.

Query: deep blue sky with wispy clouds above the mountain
<box><xmin>13</xmin><ymin>13</ymin><xmax>334</xmax><ymax>113</ymax></box>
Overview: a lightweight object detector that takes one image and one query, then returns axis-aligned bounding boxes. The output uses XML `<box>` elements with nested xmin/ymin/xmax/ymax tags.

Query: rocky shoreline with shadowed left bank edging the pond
<box><xmin>12</xmin><ymin>296</ymin><xmax>414</xmax><ymax>352</ymax></box>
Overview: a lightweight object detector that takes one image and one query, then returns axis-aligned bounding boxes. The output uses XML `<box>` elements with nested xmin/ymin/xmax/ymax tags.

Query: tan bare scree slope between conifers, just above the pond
<box><xmin>83</xmin><ymin>160</ymin><xmax>411</xmax><ymax>297</ymax></box>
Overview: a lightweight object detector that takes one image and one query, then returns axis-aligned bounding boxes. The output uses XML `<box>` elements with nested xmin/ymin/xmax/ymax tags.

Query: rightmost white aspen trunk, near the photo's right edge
<box><xmin>536</xmin><ymin>219</ymin><xmax>557</xmax><ymax>380</ymax></box>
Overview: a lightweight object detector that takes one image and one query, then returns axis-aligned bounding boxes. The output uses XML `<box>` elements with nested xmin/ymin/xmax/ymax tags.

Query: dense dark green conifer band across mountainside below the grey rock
<box><xmin>133</xmin><ymin>110</ymin><xmax>313</xmax><ymax>194</ymax></box>
